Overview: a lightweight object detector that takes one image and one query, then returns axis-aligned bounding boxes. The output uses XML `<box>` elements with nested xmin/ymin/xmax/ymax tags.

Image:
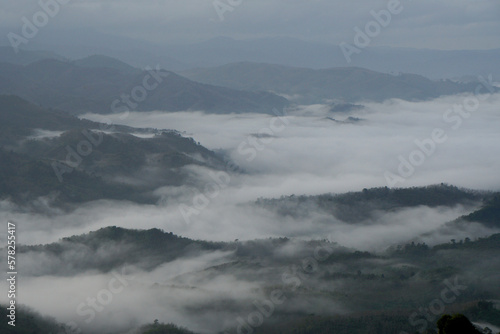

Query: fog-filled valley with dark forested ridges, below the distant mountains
<box><xmin>0</xmin><ymin>87</ymin><xmax>500</xmax><ymax>333</ymax></box>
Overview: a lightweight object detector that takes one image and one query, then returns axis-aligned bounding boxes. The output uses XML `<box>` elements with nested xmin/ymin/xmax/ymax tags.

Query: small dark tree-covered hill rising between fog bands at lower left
<box><xmin>20</xmin><ymin>226</ymin><xmax>224</xmax><ymax>276</ymax></box>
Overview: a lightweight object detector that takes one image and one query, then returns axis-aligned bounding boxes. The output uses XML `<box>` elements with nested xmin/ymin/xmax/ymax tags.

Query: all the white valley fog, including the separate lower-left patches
<box><xmin>0</xmin><ymin>94</ymin><xmax>500</xmax><ymax>333</ymax></box>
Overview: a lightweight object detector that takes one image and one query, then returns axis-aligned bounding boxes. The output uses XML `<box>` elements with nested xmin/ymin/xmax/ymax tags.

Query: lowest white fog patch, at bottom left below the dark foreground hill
<box><xmin>9</xmin><ymin>253</ymin><xmax>262</xmax><ymax>333</ymax></box>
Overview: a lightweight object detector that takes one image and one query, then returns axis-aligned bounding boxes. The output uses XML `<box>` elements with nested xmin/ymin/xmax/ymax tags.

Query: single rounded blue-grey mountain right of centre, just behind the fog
<box><xmin>182</xmin><ymin>62</ymin><xmax>477</xmax><ymax>103</ymax></box>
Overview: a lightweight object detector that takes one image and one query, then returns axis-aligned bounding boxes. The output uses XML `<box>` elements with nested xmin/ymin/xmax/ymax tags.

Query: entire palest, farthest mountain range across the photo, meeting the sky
<box><xmin>4</xmin><ymin>30</ymin><xmax>500</xmax><ymax>79</ymax></box>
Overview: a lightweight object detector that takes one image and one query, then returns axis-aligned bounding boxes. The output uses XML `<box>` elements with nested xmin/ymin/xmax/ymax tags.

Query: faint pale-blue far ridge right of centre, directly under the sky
<box><xmin>165</xmin><ymin>37</ymin><xmax>500</xmax><ymax>79</ymax></box>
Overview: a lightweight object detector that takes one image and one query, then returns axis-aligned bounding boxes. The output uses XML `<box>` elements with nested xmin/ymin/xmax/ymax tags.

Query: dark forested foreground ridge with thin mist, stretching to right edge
<box><xmin>11</xmin><ymin>226</ymin><xmax>500</xmax><ymax>334</ymax></box>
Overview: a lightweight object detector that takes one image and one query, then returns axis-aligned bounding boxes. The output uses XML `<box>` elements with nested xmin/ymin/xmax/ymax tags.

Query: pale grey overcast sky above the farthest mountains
<box><xmin>0</xmin><ymin>0</ymin><xmax>500</xmax><ymax>49</ymax></box>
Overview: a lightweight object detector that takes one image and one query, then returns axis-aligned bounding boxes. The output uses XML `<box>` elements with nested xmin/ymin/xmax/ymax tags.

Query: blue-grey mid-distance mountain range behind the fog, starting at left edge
<box><xmin>0</xmin><ymin>49</ymin><xmax>488</xmax><ymax>108</ymax></box>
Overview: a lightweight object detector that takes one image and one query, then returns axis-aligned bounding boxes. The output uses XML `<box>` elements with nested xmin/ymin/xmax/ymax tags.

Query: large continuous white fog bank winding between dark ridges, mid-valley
<box><xmin>0</xmin><ymin>95</ymin><xmax>500</xmax><ymax>249</ymax></box>
